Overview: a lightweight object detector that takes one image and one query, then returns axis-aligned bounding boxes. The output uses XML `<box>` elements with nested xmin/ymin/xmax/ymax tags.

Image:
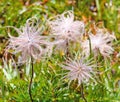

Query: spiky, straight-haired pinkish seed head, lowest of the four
<box><xmin>62</xmin><ymin>58</ymin><xmax>94</xmax><ymax>85</ymax></box>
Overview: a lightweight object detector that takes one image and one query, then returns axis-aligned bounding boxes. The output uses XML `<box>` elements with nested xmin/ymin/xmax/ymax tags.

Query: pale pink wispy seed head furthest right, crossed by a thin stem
<box><xmin>82</xmin><ymin>29</ymin><xmax>115</xmax><ymax>57</ymax></box>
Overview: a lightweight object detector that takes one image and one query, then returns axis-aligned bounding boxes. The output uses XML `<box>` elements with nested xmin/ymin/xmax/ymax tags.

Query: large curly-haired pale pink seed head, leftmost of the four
<box><xmin>7</xmin><ymin>18</ymin><xmax>51</xmax><ymax>63</ymax></box>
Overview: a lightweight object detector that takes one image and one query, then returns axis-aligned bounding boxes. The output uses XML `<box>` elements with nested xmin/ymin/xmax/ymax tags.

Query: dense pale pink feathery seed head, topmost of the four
<box><xmin>48</xmin><ymin>11</ymin><xmax>85</xmax><ymax>41</ymax></box>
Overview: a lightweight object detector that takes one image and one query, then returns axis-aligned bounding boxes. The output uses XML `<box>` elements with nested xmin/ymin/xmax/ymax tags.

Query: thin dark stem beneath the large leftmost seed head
<box><xmin>29</xmin><ymin>58</ymin><xmax>34</xmax><ymax>102</ymax></box>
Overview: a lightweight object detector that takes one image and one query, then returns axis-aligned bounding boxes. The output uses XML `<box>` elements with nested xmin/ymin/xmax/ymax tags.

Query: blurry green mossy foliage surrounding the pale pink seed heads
<box><xmin>0</xmin><ymin>0</ymin><xmax>120</xmax><ymax>102</ymax></box>
